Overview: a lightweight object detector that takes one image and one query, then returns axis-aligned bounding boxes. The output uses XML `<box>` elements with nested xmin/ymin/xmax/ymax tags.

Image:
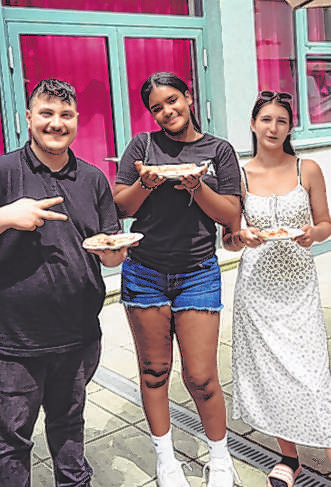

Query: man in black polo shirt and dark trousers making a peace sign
<box><xmin>0</xmin><ymin>79</ymin><xmax>126</xmax><ymax>487</ymax></box>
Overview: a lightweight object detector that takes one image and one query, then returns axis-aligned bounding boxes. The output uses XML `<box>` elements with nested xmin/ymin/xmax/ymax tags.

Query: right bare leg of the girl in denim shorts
<box><xmin>175</xmin><ymin>310</ymin><xmax>226</xmax><ymax>441</ymax></box>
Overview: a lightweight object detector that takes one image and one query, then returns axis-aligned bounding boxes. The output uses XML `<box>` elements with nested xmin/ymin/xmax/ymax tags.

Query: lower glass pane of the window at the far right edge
<box><xmin>307</xmin><ymin>58</ymin><xmax>331</xmax><ymax>123</ymax></box>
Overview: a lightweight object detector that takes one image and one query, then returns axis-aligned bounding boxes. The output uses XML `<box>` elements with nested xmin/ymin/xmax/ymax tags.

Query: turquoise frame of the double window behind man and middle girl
<box><xmin>0</xmin><ymin>0</ymin><xmax>225</xmax><ymax>156</ymax></box>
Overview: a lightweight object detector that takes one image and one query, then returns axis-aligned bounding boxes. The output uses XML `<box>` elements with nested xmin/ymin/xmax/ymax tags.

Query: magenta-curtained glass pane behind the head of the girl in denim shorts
<box><xmin>125</xmin><ymin>38</ymin><xmax>198</xmax><ymax>135</ymax></box>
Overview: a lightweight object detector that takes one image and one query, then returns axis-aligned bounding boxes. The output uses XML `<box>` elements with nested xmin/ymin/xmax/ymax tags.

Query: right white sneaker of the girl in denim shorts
<box><xmin>202</xmin><ymin>455</ymin><xmax>242</xmax><ymax>487</ymax></box>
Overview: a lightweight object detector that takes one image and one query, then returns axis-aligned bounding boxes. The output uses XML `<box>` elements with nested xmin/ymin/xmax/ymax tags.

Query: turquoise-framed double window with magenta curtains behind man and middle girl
<box><xmin>0</xmin><ymin>0</ymin><xmax>210</xmax><ymax>168</ymax></box>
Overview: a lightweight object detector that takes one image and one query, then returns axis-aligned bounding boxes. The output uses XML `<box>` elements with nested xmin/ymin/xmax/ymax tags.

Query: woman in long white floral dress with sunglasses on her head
<box><xmin>223</xmin><ymin>91</ymin><xmax>331</xmax><ymax>487</ymax></box>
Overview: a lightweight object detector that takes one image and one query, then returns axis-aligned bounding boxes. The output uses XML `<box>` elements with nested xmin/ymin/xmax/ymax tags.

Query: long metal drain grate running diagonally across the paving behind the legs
<box><xmin>93</xmin><ymin>366</ymin><xmax>331</xmax><ymax>487</ymax></box>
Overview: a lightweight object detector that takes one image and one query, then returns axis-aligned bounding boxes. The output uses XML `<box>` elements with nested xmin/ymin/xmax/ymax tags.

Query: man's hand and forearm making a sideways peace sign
<box><xmin>0</xmin><ymin>196</ymin><xmax>68</xmax><ymax>234</ymax></box>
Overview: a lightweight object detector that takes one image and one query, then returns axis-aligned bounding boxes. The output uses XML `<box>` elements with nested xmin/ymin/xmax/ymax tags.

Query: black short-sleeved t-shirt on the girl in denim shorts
<box><xmin>116</xmin><ymin>131</ymin><xmax>241</xmax><ymax>273</ymax></box>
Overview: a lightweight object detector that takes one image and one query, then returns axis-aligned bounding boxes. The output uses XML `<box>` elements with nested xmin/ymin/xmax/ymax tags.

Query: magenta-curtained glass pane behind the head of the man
<box><xmin>21</xmin><ymin>36</ymin><xmax>116</xmax><ymax>182</ymax></box>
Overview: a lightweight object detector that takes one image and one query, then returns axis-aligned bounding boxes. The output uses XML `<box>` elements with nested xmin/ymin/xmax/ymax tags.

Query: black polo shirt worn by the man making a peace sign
<box><xmin>0</xmin><ymin>143</ymin><xmax>120</xmax><ymax>356</ymax></box>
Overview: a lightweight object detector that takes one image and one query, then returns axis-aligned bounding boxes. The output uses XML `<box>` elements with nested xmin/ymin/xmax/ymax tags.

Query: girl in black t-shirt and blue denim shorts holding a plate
<box><xmin>114</xmin><ymin>72</ymin><xmax>240</xmax><ymax>487</ymax></box>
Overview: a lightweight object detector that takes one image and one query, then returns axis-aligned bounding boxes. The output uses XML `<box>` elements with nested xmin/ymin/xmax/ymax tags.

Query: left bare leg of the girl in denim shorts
<box><xmin>127</xmin><ymin>306</ymin><xmax>172</xmax><ymax>436</ymax></box>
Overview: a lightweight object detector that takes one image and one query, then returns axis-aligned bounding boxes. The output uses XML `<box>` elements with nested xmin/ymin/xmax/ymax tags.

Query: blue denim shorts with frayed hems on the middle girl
<box><xmin>121</xmin><ymin>256</ymin><xmax>223</xmax><ymax>311</ymax></box>
